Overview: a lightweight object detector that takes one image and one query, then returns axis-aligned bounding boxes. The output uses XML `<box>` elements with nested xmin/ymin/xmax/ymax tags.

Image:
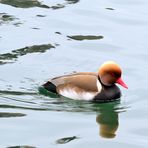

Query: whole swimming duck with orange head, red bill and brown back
<box><xmin>42</xmin><ymin>61</ymin><xmax>128</xmax><ymax>103</ymax></box>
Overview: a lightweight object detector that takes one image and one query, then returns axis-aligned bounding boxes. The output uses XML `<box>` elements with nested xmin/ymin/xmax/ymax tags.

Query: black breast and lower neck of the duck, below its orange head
<box><xmin>93</xmin><ymin>85</ymin><xmax>121</xmax><ymax>103</ymax></box>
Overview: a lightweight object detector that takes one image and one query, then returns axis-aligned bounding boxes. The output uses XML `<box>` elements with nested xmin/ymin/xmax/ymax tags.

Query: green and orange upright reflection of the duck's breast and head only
<box><xmin>96</xmin><ymin>103</ymin><xmax>119</xmax><ymax>138</ymax></box>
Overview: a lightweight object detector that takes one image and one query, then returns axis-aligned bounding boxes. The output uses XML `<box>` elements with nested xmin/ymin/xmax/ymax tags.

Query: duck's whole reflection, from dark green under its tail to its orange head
<box><xmin>39</xmin><ymin>87</ymin><xmax>119</xmax><ymax>138</ymax></box>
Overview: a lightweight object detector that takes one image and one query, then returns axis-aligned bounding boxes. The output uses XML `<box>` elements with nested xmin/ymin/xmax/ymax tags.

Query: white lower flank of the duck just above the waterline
<box><xmin>59</xmin><ymin>89</ymin><xmax>96</xmax><ymax>101</ymax></box>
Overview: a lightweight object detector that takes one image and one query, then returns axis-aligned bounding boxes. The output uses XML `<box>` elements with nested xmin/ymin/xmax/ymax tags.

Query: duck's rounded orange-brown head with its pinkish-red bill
<box><xmin>98</xmin><ymin>61</ymin><xmax>128</xmax><ymax>88</ymax></box>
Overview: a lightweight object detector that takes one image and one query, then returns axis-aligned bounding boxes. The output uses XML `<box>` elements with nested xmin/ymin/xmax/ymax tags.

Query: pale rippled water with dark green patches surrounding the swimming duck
<box><xmin>0</xmin><ymin>0</ymin><xmax>148</xmax><ymax>148</ymax></box>
